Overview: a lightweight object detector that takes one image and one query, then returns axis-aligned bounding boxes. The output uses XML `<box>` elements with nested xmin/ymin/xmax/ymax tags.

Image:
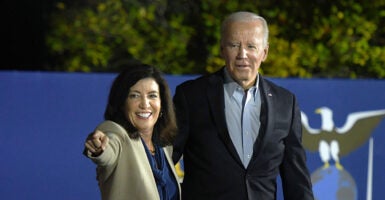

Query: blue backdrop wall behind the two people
<box><xmin>0</xmin><ymin>71</ymin><xmax>385</xmax><ymax>200</ymax></box>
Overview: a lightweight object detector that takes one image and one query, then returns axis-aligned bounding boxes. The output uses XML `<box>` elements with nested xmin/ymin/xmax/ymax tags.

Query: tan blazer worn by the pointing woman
<box><xmin>88</xmin><ymin>121</ymin><xmax>181</xmax><ymax>200</ymax></box>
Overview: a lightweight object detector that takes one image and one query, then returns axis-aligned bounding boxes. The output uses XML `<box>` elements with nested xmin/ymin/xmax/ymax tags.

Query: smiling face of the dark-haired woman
<box><xmin>124</xmin><ymin>78</ymin><xmax>161</xmax><ymax>134</ymax></box>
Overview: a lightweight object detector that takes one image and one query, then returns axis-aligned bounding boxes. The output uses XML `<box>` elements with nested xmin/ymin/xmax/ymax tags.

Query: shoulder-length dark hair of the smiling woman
<box><xmin>104</xmin><ymin>64</ymin><xmax>177</xmax><ymax>146</ymax></box>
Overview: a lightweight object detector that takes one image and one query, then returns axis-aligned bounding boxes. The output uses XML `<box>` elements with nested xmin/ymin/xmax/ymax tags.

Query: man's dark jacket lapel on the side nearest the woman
<box><xmin>206</xmin><ymin>69</ymin><xmax>243</xmax><ymax>166</ymax></box>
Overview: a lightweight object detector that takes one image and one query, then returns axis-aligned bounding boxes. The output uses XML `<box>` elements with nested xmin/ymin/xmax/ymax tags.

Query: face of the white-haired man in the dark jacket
<box><xmin>221</xmin><ymin>20</ymin><xmax>268</xmax><ymax>89</ymax></box>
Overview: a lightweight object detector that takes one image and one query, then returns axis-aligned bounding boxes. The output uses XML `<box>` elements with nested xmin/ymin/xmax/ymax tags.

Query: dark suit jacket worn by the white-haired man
<box><xmin>173</xmin><ymin>68</ymin><xmax>313</xmax><ymax>200</ymax></box>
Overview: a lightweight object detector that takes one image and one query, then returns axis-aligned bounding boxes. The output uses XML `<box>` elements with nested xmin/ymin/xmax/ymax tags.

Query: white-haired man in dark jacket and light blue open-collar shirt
<box><xmin>173</xmin><ymin>12</ymin><xmax>313</xmax><ymax>200</ymax></box>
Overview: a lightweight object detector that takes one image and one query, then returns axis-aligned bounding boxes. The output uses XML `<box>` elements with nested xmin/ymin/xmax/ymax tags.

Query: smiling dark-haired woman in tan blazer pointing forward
<box><xmin>85</xmin><ymin>65</ymin><xmax>180</xmax><ymax>200</ymax></box>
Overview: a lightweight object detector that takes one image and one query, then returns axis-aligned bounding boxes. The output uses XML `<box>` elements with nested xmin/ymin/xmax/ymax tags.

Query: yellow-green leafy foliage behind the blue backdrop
<box><xmin>46</xmin><ymin>0</ymin><xmax>385</xmax><ymax>78</ymax></box>
